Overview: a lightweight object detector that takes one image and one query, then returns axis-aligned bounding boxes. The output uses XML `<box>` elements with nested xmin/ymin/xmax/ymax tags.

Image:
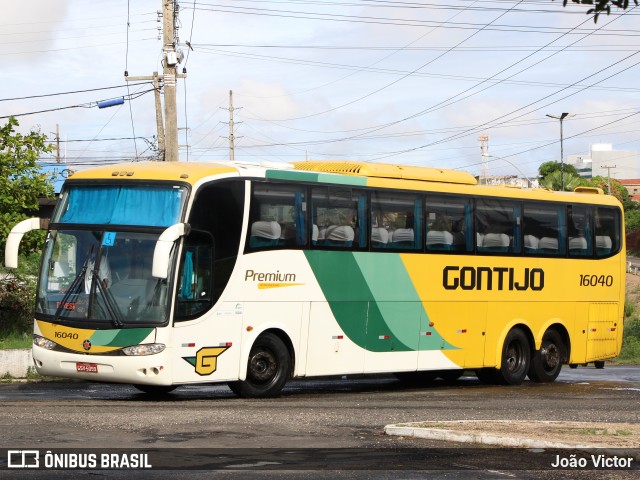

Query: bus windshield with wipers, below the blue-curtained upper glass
<box><xmin>36</xmin><ymin>229</ymin><xmax>167</xmax><ymax>327</ymax></box>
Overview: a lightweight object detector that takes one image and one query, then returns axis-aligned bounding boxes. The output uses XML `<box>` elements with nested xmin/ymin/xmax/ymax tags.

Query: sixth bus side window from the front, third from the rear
<box><xmin>524</xmin><ymin>203</ymin><xmax>564</xmax><ymax>256</ymax></box>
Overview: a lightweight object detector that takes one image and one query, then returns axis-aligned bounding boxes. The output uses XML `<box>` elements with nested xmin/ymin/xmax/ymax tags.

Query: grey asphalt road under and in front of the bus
<box><xmin>0</xmin><ymin>367</ymin><xmax>640</xmax><ymax>479</ymax></box>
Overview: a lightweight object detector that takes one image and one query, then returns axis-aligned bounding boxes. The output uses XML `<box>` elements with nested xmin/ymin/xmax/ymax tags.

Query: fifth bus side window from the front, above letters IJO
<box><xmin>476</xmin><ymin>198</ymin><xmax>522</xmax><ymax>253</ymax></box>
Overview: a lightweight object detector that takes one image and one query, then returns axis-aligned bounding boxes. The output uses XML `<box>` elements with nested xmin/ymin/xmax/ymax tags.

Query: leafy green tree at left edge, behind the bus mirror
<box><xmin>0</xmin><ymin>117</ymin><xmax>53</xmax><ymax>252</ymax></box>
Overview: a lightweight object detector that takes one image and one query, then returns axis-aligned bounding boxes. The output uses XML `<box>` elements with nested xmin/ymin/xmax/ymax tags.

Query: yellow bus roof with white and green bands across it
<box><xmin>67</xmin><ymin>161</ymin><xmax>619</xmax><ymax>205</ymax></box>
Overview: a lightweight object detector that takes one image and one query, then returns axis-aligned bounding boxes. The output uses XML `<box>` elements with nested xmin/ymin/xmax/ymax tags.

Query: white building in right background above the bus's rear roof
<box><xmin>567</xmin><ymin>143</ymin><xmax>640</xmax><ymax>180</ymax></box>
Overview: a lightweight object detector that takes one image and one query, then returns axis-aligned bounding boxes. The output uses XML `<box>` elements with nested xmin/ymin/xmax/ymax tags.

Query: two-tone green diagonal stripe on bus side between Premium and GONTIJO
<box><xmin>305</xmin><ymin>251</ymin><xmax>456</xmax><ymax>352</ymax></box>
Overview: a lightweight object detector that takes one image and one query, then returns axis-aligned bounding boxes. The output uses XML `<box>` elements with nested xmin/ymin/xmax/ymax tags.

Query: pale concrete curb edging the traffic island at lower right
<box><xmin>384</xmin><ymin>422</ymin><xmax>640</xmax><ymax>457</ymax></box>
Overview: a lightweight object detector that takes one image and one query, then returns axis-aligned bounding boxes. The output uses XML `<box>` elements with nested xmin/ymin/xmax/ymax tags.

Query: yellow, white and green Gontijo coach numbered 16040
<box><xmin>5</xmin><ymin>161</ymin><xmax>625</xmax><ymax>397</ymax></box>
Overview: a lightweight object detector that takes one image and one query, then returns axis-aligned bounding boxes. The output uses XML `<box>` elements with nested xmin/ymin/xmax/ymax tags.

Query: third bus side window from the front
<box><xmin>371</xmin><ymin>191</ymin><xmax>422</xmax><ymax>250</ymax></box>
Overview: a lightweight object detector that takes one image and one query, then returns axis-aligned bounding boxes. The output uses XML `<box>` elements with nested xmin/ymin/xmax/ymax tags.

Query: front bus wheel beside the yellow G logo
<box><xmin>228</xmin><ymin>333</ymin><xmax>291</xmax><ymax>398</ymax></box>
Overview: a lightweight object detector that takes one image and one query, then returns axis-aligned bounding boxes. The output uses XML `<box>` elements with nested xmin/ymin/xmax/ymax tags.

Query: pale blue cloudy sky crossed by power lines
<box><xmin>0</xmin><ymin>0</ymin><xmax>640</xmax><ymax>176</ymax></box>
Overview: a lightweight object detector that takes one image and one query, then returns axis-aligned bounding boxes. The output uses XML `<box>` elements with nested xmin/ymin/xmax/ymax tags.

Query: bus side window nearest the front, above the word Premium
<box><xmin>248</xmin><ymin>183</ymin><xmax>307</xmax><ymax>250</ymax></box>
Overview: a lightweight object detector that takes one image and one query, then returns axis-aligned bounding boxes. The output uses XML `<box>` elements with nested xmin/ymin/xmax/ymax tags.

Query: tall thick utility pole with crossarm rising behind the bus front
<box><xmin>124</xmin><ymin>0</ymin><xmax>186</xmax><ymax>162</ymax></box>
